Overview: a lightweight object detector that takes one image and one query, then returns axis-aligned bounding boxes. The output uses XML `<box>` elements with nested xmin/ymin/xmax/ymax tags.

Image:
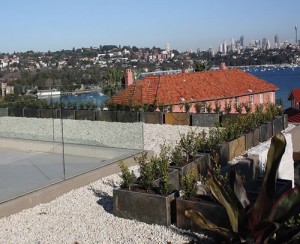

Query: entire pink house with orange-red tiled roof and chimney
<box><xmin>108</xmin><ymin>65</ymin><xmax>278</xmax><ymax>113</ymax></box>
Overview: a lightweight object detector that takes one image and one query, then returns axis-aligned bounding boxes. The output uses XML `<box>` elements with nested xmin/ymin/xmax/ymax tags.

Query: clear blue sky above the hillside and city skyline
<box><xmin>0</xmin><ymin>0</ymin><xmax>300</xmax><ymax>53</ymax></box>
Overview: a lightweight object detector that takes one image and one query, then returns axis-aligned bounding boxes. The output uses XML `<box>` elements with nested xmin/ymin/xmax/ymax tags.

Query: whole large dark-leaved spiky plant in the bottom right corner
<box><xmin>185</xmin><ymin>133</ymin><xmax>300</xmax><ymax>243</ymax></box>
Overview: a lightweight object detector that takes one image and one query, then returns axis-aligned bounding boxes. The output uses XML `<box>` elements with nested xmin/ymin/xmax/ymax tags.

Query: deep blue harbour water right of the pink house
<box><xmin>247</xmin><ymin>67</ymin><xmax>300</xmax><ymax>109</ymax></box>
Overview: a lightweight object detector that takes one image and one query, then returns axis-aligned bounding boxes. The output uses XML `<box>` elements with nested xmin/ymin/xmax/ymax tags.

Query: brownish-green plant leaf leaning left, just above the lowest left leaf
<box><xmin>208</xmin><ymin>170</ymin><xmax>241</xmax><ymax>232</ymax></box>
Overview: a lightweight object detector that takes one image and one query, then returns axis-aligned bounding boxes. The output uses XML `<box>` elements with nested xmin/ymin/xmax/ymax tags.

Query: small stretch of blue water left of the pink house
<box><xmin>52</xmin><ymin>92</ymin><xmax>108</xmax><ymax>108</ymax></box>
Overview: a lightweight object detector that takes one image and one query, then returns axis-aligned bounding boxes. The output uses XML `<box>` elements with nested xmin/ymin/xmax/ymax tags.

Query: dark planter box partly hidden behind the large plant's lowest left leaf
<box><xmin>176</xmin><ymin>197</ymin><xmax>231</xmax><ymax>233</ymax></box>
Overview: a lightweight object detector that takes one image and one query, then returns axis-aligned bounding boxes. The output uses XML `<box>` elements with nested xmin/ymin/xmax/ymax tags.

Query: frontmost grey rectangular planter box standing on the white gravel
<box><xmin>113</xmin><ymin>188</ymin><xmax>177</xmax><ymax>226</ymax></box>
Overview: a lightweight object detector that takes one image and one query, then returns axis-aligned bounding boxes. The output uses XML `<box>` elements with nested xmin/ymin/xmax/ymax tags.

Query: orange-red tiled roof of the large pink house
<box><xmin>108</xmin><ymin>69</ymin><xmax>278</xmax><ymax>105</ymax></box>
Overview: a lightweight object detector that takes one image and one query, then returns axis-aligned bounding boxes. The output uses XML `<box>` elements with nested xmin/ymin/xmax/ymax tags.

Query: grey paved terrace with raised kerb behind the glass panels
<box><xmin>0</xmin><ymin>138</ymin><xmax>141</xmax><ymax>218</ymax></box>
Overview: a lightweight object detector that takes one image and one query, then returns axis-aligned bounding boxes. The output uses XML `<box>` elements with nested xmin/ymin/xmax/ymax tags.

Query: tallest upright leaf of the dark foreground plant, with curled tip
<box><xmin>249</xmin><ymin>133</ymin><xmax>286</xmax><ymax>231</ymax></box>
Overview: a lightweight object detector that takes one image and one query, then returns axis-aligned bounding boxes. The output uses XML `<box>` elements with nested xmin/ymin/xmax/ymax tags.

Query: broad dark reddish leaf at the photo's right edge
<box><xmin>268</xmin><ymin>185</ymin><xmax>300</xmax><ymax>222</ymax></box>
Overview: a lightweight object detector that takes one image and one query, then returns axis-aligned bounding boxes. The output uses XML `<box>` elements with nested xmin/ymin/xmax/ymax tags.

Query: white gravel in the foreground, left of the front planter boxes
<box><xmin>0</xmin><ymin>166</ymin><xmax>196</xmax><ymax>244</ymax></box>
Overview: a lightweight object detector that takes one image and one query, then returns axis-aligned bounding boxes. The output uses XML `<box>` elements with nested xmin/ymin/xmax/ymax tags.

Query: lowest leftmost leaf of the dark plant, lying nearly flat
<box><xmin>184</xmin><ymin>210</ymin><xmax>231</xmax><ymax>238</ymax></box>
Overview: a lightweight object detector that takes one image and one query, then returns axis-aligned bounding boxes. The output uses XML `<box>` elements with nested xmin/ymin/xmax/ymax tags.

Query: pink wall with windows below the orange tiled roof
<box><xmin>173</xmin><ymin>92</ymin><xmax>276</xmax><ymax>113</ymax></box>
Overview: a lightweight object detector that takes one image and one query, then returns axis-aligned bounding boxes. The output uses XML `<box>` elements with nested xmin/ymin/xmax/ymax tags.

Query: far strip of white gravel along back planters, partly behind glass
<box><xmin>0</xmin><ymin>117</ymin><xmax>208</xmax><ymax>153</ymax></box>
